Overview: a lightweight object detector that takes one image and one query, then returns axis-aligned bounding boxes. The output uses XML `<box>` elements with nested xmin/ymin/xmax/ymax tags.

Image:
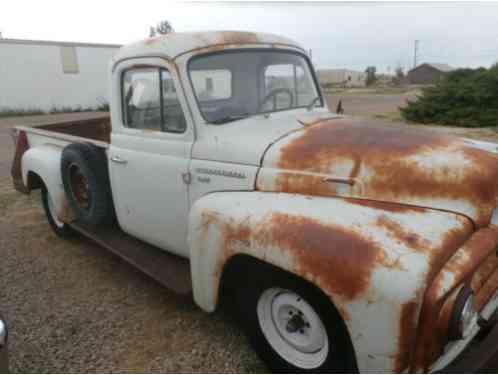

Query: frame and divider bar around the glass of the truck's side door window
<box><xmin>119</xmin><ymin>64</ymin><xmax>188</xmax><ymax>134</ymax></box>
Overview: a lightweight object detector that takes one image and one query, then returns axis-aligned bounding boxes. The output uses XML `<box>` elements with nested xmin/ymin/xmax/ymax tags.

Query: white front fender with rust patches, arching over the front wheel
<box><xmin>189</xmin><ymin>192</ymin><xmax>472</xmax><ymax>372</ymax></box>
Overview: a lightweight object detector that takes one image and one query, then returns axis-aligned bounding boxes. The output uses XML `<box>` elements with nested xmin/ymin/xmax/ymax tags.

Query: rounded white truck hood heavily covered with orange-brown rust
<box><xmin>256</xmin><ymin>114</ymin><xmax>498</xmax><ymax>227</ymax></box>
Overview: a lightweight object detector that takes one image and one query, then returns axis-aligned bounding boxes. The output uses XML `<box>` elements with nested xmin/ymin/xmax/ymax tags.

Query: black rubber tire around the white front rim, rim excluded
<box><xmin>238</xmin><ymin>267</ymin><xmax>358</xmax><ymax>373</ymax></box>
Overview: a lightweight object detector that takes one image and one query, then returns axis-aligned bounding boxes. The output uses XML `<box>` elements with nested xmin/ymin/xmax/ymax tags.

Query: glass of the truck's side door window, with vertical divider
<box><xmin>122</xmin><ymin>68</ymin><xmax>186</xmax><ymax>133</ymax></box>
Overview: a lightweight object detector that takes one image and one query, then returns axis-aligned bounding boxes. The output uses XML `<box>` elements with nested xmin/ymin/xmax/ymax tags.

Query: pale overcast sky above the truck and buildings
<box><xmin>0</xmin><ymin>0</ymin><xmax>498</xmax><ymax>72</ymax></box>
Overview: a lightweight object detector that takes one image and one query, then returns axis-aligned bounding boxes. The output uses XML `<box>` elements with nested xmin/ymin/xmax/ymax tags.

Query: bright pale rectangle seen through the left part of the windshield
<box><xmin>190</xmin><ymin>69</ymin><xmax>232</xmax><ymax>102</ymax></box>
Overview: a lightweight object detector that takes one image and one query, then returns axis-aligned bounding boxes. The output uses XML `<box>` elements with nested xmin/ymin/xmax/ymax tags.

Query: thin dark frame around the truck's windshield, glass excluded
<box><xmin>187</xmin><ymin>47</ymin><xmax>325</xmax><ymax>126</ymax></box>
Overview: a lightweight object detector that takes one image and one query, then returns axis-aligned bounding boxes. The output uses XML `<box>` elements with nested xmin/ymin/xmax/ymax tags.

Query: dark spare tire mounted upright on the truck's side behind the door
<box><xmin>61</xmin><ymin>143</ymin><xmax>114</xmax><ymax>225</ymax></box>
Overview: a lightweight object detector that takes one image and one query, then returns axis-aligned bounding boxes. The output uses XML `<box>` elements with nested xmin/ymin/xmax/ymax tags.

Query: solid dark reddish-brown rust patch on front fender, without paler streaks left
<box><xmin>262</xmin><ymin>213</ymin><xmax>386</xmax><ymax>300</ymax></box>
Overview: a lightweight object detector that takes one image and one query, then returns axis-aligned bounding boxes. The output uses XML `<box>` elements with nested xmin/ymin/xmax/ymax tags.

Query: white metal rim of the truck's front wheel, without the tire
<box><xmin>257</xmin><ymin>288</ymin><xmax>329</xmax><ymax>370</ymax></box>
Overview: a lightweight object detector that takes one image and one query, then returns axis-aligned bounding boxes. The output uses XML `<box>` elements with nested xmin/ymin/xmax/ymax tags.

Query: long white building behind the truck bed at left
<box><xmin>0</xmin><ymin>39</ymin><xmax>120</xmax><ymax>111</ymax></box>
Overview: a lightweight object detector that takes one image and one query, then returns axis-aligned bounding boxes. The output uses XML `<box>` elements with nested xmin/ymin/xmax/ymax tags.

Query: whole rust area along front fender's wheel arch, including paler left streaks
<box><xmin>206</xmin><ymin>212</ymin><xmax>390</xmax><ymax>310</ymax></box>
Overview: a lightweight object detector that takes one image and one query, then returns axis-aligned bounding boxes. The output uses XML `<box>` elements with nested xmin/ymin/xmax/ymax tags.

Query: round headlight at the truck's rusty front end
<box><xmin>449</xmin><ymin>287</ymin><xmax>478</xmax><ymax>340</ymax></box>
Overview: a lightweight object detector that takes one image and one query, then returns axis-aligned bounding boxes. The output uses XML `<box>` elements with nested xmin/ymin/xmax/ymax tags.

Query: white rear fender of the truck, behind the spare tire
<box><xmin>21</xmin><ymin>145</ymin><xmax>74</xmax><ymax>222</ymax></box>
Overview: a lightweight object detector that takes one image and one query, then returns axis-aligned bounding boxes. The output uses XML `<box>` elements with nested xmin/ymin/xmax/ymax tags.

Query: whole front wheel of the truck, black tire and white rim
<box><xmin>239</xmin><ymin>271</ymin><xmax>357</xmax><ymax>373</ymax></box>
